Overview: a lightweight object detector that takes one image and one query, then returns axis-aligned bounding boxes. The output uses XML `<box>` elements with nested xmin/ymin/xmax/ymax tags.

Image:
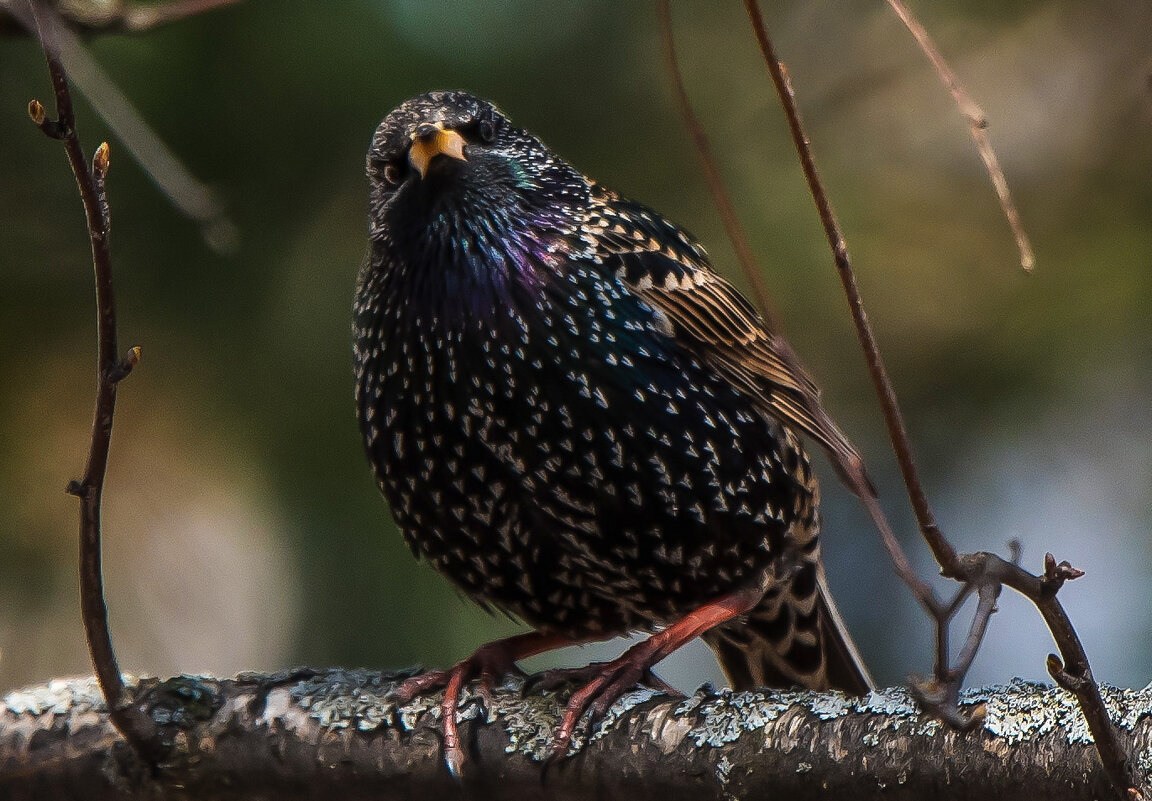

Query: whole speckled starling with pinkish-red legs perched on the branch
<box><xmin>353</xmin><ymin>91</ymin><xmax>872</xmax><ymax>774</ymax></box>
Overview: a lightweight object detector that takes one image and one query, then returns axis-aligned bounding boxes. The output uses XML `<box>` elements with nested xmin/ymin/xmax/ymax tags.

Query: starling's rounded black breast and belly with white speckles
<box><xmin>356</xmin><ymin>265</ymin><xmax>817</xmax><ymax>636</ymax></box>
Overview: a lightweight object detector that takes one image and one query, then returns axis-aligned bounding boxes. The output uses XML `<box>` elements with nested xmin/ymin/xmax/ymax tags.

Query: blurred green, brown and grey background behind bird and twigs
<box><xmin>0</xmin><ymin>0</ymin><xmax>1152</xmax><ymax>692</ymax></box>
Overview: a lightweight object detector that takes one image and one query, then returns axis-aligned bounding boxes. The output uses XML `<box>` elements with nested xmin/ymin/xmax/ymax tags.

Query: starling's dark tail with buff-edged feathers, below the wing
<box><xmin>704</xmin><ymin>561</ymin><xmax>873</xmax><ymax>695</ymax></box>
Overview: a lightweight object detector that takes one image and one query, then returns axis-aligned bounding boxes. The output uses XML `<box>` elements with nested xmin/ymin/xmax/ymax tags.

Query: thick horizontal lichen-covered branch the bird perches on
<box><xmin>0</xmin><ymin>670</ymin><xmax>1152</xmax><ymax>801</ymax></box>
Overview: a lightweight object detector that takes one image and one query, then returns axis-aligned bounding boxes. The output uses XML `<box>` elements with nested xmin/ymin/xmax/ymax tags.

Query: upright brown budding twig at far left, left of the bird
<box><xmin>29</xmin><ymin>0</ymin><xmax>159</xmax><ymax>758</ymax></box>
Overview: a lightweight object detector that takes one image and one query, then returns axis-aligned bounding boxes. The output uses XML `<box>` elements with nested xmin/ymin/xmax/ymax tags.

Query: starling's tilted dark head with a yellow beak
<box><xmin>367</xmin><ymin>92</ymin><xmax>589</xmax><ymax>260</ymax></box>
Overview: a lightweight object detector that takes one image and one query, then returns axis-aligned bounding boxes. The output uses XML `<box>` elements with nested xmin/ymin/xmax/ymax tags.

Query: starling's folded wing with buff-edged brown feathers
<box><xmin>586</xmin><ymin>187</ymin><xmax>871</xmax><ymax>493</ymax></box>
